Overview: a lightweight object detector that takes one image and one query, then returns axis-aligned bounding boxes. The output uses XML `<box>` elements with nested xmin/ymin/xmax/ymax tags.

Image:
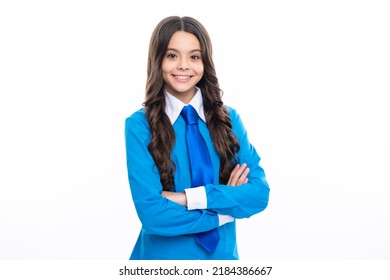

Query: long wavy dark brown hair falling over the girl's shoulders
<box><xmin>143</xmin><ymin>16</ymin><xmax>240</xmax><ymax>190</ymax></box>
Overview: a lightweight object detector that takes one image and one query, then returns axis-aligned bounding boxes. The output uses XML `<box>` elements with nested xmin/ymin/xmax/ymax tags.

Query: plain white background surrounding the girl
<box><xmin>0</xmin><ymin>0</ymin><xmax>390</xmax><ymax>260</ymax></box>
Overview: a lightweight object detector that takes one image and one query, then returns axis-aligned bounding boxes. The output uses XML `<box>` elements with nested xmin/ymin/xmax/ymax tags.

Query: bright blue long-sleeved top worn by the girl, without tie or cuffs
<box><xmin>125</xmin><ymin>107</ymin><xmax>269</xmax><ymax>260</ymax></box>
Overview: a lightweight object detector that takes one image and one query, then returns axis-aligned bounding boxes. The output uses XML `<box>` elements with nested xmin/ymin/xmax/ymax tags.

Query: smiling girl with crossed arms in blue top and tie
<box><xmin>125</xmin><ymin>16</ymin><xmax>269</xmax><ymax>260</ymax></box>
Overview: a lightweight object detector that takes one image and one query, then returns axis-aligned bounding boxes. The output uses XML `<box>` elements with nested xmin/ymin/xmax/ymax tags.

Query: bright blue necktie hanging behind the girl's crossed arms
<box><xmin>181</xmin><ymin>105</ymin><xmax>219</xmax><ymax>253</ymax></box>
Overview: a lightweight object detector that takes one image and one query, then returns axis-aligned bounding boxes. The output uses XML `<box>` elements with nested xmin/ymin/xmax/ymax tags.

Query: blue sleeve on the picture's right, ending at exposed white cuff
<box><xmin>206</xmin><ymin>108</ymin><xmax>269</xmax><ymax>218</ymax></box>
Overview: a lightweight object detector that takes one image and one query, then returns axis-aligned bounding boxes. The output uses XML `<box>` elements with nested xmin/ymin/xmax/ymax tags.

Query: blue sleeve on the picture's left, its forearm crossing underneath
<box><xmin>125</xmin><ymin>111</ymin><xmax>218</xmax><ymax>236</ymax></box>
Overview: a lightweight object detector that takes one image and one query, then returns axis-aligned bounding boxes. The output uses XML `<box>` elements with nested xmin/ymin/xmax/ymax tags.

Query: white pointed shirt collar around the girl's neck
<box><xmin>164</xmin><ymin>87</ymin><xmax>206</xmax><ymax>124</ymax></box>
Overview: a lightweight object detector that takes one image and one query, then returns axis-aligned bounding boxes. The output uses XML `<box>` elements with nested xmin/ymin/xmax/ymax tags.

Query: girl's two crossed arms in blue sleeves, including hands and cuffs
<box><xmin>125</xmin><ymin>108</ymin><xmax>269</xmax><ymax>236</ymax></box>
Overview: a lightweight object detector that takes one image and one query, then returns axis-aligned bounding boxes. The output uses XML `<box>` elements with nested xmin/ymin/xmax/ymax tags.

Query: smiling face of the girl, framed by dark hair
<box><xmin>162</xmin><ymin>31</ymin><xmax>204</xmax><ymax>104</ymax></box>
